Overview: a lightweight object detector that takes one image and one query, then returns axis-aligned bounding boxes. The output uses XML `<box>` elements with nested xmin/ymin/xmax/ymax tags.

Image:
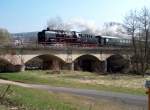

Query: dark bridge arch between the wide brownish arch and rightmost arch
<box><xmin>73</xmin><ymin>54</ymin><xmax>101</xmax><ymax>72</ymax></box>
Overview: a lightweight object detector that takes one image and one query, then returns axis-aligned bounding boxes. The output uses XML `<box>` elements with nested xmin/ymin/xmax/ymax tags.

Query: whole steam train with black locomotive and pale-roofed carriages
<box><xmin>37</xmin><ymin>28</ymin><xmax>131</xmax><ymax>47</ymax></box>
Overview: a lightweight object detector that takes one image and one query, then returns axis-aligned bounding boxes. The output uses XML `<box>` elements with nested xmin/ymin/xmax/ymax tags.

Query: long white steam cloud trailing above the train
<box><xmin>47</xmin><ymin>17</ymin><xmax>126</xmax><ymax>36</ymax></box>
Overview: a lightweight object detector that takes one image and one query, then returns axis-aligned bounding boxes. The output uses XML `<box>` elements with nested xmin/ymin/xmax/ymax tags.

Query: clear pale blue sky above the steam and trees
<box><xmin>0</xmin><ymin>0</ymin><xmax>150</xmax><ymax>33</ymax></box>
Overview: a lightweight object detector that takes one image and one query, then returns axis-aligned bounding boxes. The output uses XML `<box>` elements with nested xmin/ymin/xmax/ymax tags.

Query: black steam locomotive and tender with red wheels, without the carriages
<box><xmin>38</xmin><ymin>29</ymin><xmax>98</xmax><ymax>46</ymax></box>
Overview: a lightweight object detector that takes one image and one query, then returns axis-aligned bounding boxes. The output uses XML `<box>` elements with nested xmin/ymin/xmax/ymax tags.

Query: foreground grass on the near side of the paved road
<box><xmin>0</xmin><ymin>85</ymin><xmax>143</xmax><ymax>110</ymax></box>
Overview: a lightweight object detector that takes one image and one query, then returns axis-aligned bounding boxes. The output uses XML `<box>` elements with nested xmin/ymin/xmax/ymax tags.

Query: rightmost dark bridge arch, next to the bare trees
<box><xmin>106</xmin><ymin>54</ymin><xmax>129</xmax><ymax>73</ymax></box>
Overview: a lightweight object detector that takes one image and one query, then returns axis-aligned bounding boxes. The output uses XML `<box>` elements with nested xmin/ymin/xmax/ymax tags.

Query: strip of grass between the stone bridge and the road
<box><xmin>0</xmin><ymin>71</ymin><xmax>149</xmax><ymax>95</ymax></box>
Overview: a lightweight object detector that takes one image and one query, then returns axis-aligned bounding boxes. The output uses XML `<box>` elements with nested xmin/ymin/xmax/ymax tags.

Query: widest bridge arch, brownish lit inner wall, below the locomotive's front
<box><xmin>25</xmin><ymin>54</ymin><xmax>65</xmax><ymax>70</ymax></box>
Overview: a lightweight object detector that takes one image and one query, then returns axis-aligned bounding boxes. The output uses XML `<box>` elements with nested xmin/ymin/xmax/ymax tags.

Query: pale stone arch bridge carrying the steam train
<box><xmin>0</xmin><ymin>47</ymin><xmax>132</xmax><ymax>72</ymax></box>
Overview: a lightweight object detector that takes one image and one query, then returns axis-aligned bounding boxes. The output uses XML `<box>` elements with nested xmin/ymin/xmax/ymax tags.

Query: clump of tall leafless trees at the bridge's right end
<box><xmin>125</xmin><ymin>7</ymin><xmax>150</xmax><ymax>75</ymax></box>
